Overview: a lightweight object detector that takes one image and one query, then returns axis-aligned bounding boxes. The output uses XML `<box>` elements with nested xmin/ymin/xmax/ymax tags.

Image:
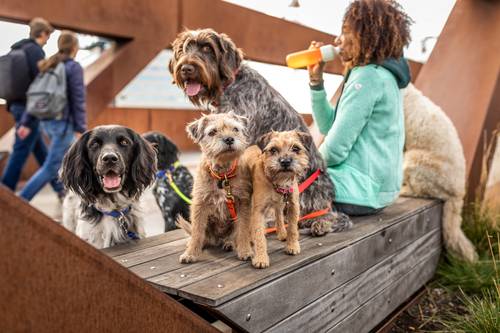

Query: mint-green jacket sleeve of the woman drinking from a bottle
<box><xmin>319</xmin><ymin>71</ymin><xmax>381</xmax><ymax>166</ymax></box>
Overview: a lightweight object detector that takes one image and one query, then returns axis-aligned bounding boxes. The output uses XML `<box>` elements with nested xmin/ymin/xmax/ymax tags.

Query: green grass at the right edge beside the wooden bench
<box><xmin>436</xmin><ymin>205</ymin><xmax>500</xmax><ymax>333</ymax></box>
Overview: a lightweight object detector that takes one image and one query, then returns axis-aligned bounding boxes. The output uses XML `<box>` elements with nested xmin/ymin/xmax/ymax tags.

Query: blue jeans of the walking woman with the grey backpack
<box><xmin>20</xmin><ymin>120</ymin><xmax>75</xmax><ymax>201</ymax></box>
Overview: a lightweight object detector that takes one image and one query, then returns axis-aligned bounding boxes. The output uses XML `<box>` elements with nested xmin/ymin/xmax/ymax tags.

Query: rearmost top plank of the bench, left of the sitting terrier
<box><xmin>102</xmin><ymin>229</ymin><xmax>188</xmax><ymax>257</ymax></box>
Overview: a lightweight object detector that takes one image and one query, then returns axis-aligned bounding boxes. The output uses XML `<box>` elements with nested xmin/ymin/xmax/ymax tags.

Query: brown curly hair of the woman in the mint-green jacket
<box><xmin>342</xmin><ymin>0</ymin><xmax>413</xmax><ymax>68</ymax></box>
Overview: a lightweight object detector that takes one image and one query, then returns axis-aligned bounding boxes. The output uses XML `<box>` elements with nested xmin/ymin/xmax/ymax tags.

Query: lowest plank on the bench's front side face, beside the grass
<box><xmin>327</xmin><ymin>251</ymin><xmax>440</xmax><ymax>333</ymax></box>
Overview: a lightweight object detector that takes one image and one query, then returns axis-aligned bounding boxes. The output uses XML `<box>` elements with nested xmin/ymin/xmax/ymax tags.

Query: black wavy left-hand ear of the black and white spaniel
<box><xmin>59</xmin><ymin>131</ymin><xmax>100</xmax><ymax>204</ymax></box>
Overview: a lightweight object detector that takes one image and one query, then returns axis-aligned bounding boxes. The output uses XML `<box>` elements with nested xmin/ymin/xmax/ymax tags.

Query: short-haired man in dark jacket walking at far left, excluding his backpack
<box><xmin>1</xmin><ymin>18</ymin><xmax>63</xmax><ymax>195</ymax></box>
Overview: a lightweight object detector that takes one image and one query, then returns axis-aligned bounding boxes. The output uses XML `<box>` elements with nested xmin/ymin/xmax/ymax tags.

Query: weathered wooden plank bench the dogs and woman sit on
<box><xmin>105</xmin><ymin>198</ymin><xmax>442</xmax><ymax>332</ymax></box>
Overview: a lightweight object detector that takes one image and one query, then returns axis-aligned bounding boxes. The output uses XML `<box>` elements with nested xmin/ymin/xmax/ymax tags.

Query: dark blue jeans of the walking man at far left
<box><xmin>1</xmin><ymin>103</ymin><xmax>64</xmax><ymax>193</ymax></box>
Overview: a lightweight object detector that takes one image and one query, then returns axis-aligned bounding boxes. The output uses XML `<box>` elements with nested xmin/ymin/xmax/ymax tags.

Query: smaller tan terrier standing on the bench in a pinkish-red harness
<box><xmin>245</xmin><ymin>131</ymin><xmax>312</xmax><ymax>268</ymax></box>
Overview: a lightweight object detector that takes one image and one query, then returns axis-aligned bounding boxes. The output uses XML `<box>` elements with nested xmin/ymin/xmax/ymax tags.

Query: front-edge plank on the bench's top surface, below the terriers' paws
<box><xmin>178</xmin><ymin>199</ymin><xmax>441</xmax><ymax>306</ymax></box>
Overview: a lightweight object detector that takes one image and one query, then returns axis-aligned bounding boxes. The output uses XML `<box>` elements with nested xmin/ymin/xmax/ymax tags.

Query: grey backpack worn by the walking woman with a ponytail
<box><xmin>26</xmin><ymin>62</ymin><xmax>67</xmax><ymax>120</ymax></box>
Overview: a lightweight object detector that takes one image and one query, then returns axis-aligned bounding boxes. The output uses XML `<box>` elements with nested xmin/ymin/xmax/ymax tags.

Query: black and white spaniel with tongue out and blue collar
<box><xmin>61</xmin><ymin>125</ymin><xmax>156</xmax><ymax>248</ymax></box>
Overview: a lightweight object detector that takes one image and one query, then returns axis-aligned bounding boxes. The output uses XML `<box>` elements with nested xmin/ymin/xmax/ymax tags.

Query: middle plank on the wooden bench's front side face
<box><xmin>264</xmin><ymin>228</ymin><xmax>441</xmax><ymax>332</ymax></box>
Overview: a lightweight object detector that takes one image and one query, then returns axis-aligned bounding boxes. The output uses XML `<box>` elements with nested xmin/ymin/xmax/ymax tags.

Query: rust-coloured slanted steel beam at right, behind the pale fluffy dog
<box><xmin>416</xmin><ymin>0</ymin><xmax>500</xmax><ymax>195</ymax></box>
